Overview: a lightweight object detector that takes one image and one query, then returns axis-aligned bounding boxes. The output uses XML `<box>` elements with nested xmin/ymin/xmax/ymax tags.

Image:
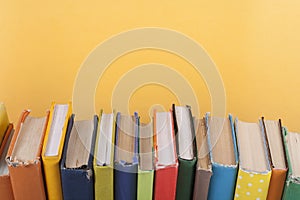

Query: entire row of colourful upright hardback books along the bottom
<box><xmin>0</xmin><ymin>103</ymin><xmax>300</xmax><ymax>200</ymax></box>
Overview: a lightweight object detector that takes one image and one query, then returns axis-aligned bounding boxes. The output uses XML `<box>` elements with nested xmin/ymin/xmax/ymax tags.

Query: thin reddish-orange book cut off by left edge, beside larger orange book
<box><xmin>0</xmin><ymin>124</ymin><xmax>14</xmax><ymax>200</ymax></box>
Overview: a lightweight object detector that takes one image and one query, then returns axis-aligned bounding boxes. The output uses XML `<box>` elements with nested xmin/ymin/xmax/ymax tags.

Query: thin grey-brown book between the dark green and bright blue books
<box><xmin>193</xmin><ymin>118</ymin><xmax>212</xmax><ymax>200</ymax></box>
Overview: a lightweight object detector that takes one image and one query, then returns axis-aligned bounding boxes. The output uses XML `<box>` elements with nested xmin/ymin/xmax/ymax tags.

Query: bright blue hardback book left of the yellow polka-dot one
<box><xmin>206</xmin><ymin>113</ymin><xmax>238</xmax><ymax>200</ymax></box>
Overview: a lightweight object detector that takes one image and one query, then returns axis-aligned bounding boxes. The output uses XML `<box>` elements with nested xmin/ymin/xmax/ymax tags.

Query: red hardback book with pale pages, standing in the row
<box><xmin>153</xmin><ymin>111</ymin><xmax>178</xmax><ymax>200</ymax></box>
